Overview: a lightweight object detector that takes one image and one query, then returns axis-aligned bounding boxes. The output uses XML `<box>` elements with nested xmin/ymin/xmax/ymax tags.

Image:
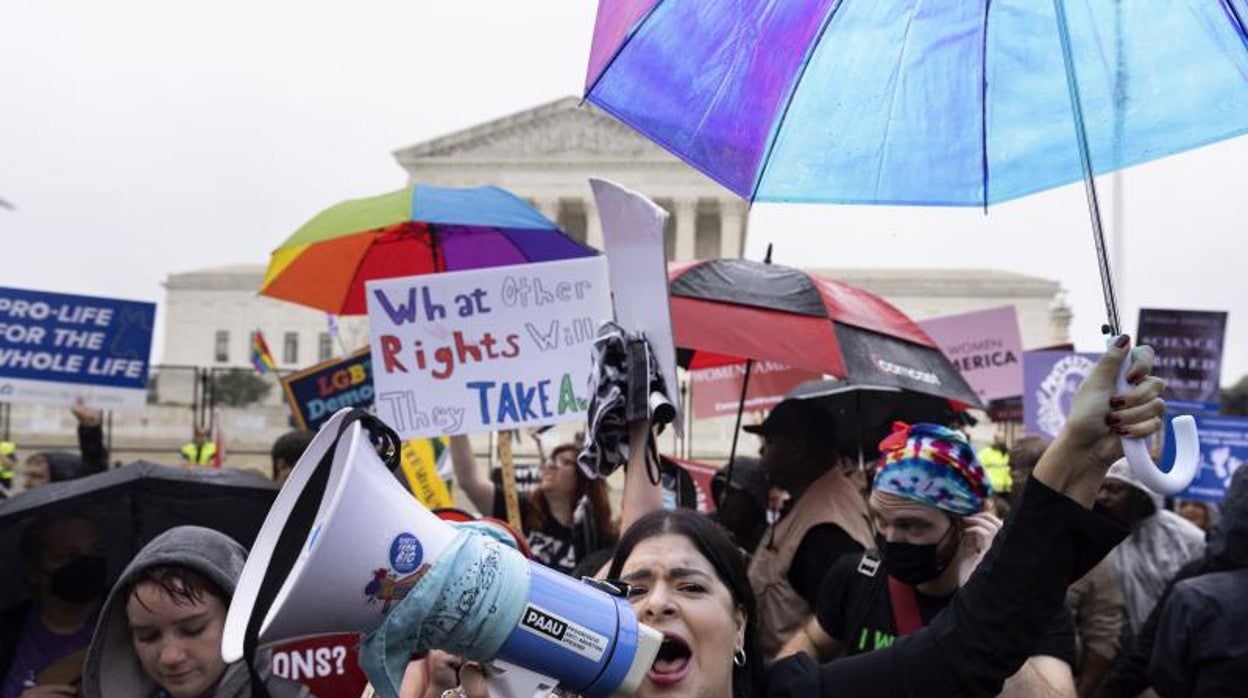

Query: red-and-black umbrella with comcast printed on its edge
<box><xmin>668</xmin><ymin>260</ymin><xmax>981</xmax><ymax>407</ymax></box>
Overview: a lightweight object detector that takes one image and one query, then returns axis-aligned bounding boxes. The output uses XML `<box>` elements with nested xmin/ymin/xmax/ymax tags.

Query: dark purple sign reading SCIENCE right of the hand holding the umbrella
<box><xmin>1137</xmin><ymin>308</ymin><xmax>1227</xmax><ymax>413</ymax></box>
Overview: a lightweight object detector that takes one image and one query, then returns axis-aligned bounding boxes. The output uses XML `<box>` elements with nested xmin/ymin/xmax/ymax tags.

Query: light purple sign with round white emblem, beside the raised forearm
<box><xmin>1022</xmin><ymin>351</ymin><xmax>1101</xmax><ymax>438</ymax></box>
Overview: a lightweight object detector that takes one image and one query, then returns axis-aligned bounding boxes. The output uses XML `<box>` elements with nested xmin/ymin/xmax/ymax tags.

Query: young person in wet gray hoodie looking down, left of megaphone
<box><xmin>82</xmin><ymin>526</ymin><xmax>308</xmax><ymax>698</ymax></box>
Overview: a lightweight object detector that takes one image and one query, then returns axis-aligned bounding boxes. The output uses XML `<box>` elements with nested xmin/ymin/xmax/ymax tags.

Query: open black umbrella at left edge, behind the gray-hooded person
<box><xmin>0</xmin><ymin>461</ymin><xmax>277</xmax><ymax>608</ymax></box>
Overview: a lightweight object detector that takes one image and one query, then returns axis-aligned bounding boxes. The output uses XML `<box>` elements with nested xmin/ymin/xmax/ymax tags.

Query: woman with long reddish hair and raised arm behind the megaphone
<box><xmin>451</xmin><ymin>436</ymin><xmax>615</xmax><ymax>574</ymax></box>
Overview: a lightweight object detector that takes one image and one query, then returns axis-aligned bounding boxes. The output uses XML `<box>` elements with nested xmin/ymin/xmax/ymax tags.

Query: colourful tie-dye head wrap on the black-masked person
<box><xmin>874</xmin><ymin>422</ymin><xmax>992</xmax><ymax>516</ymax></box>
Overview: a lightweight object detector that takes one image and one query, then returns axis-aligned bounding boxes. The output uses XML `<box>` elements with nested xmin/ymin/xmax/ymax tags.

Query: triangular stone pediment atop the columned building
<box><xmin>394</xmin><ymin>97</ymin><xmax>679</xmax><ymax>165</ymax></box>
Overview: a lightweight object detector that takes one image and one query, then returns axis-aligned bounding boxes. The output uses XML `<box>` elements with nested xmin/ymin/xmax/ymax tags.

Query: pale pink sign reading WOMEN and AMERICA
<box><xmin>919</xmin><ymin>306</ymin><xmax>1022</xmax><ymax>403</ymax></box>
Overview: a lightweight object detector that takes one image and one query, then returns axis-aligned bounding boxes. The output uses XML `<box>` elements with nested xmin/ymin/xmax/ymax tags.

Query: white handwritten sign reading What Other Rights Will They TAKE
<box><xmin>366</xmin><ymin>257</ymin><xmax>612</xmax><ymax>440</ymax></box>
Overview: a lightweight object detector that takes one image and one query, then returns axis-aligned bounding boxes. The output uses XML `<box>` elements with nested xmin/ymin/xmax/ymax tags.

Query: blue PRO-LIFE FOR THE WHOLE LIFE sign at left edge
<box><xmin>0</xmin><ymin>287</ymin><xmax>156</xmax><ymax>410</ymax></box>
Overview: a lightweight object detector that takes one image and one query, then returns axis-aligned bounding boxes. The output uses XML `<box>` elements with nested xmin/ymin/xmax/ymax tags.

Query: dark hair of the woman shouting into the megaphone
<box><xmin>607</xmin><ymin>509</ymin><xmax>763</xmax><ymax>698</ymax></box>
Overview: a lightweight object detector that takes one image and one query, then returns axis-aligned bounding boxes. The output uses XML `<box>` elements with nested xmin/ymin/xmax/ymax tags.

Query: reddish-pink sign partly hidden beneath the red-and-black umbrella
<box><xmin>689</xmin><ymin>361</ymin><xmax>822</xmax><ymax>420</ymax></box>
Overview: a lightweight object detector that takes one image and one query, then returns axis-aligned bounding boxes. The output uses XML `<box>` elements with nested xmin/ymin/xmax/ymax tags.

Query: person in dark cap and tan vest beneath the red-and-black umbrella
<box><xmin>745</xmin><ymin>400</ymin><xmax>871</xmax><ymax>658</ymax></box>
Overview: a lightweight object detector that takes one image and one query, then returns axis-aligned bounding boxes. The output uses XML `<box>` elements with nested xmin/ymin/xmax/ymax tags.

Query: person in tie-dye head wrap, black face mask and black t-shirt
<box><xmin>781</xmin><ymin>425</ymin><xmax>1075</xmax><ymax>691</ymax></box>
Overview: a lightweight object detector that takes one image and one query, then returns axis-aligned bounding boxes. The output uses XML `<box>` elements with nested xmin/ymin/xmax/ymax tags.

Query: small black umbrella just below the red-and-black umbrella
<box><xmin>785</xmin><ymin>380</ymin><xmax>957</xmax><ymax>461</ymax></box>
